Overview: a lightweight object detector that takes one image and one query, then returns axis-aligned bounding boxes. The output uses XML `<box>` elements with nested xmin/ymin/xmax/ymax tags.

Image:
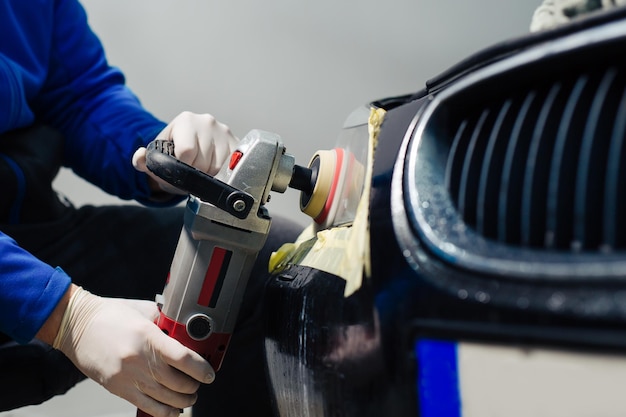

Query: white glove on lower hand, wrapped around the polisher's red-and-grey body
<box><xmin>53</xmin><ymin>288</ymin><xmax>215</xmax><ymax>417</ymax></box>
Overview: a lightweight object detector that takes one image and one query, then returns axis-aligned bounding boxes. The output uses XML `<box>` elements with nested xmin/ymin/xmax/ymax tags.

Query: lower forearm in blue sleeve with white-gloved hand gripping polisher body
<box><xmin>0</xmin><ymin>228</ymin><xmax>215</xmax><ymax>417</ymax></box>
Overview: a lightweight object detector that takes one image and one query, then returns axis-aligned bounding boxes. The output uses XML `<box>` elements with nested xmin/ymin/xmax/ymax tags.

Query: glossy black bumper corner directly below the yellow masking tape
<box><xmin>266</xmin><ymin>267</ymin><xmax>410</xmax><ymax>416</ymax></box>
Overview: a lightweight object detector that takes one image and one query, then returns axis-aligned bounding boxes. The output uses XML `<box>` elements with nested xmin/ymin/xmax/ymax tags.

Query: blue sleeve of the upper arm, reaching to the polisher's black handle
<box><xmin>33</xmin><ymin>0</ymin><xmax>171</xmax><ymax>205</ymax></box>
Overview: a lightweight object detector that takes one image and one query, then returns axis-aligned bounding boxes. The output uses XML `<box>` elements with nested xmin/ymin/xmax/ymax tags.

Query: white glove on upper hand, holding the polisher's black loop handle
<box><xmin>133</xmin><ymin>112</ymin><xmax>239</xmax><ymax>194</ymax></box>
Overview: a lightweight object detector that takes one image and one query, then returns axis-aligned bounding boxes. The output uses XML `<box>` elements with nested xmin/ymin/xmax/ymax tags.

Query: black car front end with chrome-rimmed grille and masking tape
<box><xmin>265</xmin><ymin>8</ymin><xmax>626</xmax><ymax>417</ymax></box>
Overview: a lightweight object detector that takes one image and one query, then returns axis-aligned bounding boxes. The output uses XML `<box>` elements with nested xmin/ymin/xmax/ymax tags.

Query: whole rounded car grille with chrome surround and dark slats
<box><xmin>392</xmin><ymin>22</ymin><xmax>626</xmax><ymax>280</ymax></box>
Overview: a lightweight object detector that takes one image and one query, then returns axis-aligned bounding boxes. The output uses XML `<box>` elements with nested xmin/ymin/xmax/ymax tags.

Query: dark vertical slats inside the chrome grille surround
<box><xmin>445</xmin><ymin>63</ymin><xmax>626</xmax><ymax>252</ymax></box>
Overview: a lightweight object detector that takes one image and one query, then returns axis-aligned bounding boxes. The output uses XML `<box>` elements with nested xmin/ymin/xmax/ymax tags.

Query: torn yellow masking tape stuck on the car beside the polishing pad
<box><xmin>270</xmin><ymin>108</ymin><xmax>385</xmax><ymax>297</ymax></box>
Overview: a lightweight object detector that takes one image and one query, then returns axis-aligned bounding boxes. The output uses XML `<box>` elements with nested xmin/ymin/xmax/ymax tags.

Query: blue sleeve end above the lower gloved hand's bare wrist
<box><xmin>0</xmin><ymin>232</ymin><xmax>70</xmax><ymax>343</ymax></box>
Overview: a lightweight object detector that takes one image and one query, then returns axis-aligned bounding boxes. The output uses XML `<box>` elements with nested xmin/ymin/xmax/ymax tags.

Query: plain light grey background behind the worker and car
<box><xmin>26</xmin><ymin>0</ymin><xmax>540</xmax><ymax>417</ymax></box>
